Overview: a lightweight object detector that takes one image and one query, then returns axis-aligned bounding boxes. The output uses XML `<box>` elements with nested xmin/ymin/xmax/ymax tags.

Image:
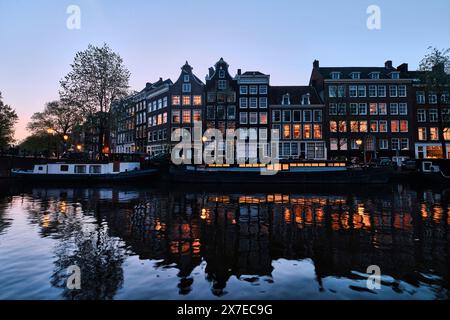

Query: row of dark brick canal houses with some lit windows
<box><xmin>111</xmin><ymin>58</ymin><xmax>450</xmax><ymax>162</ymax></box>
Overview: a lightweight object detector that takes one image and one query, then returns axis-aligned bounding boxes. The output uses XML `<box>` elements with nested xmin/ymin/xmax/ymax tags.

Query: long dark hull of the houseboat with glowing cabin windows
<box><xmin>170</xmin><ymin>168</ymin><xmax>393</xmax><ymax>184</ymax></box>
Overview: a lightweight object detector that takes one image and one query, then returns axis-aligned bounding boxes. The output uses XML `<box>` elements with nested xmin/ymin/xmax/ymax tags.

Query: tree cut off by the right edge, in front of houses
<box><xmin>419</xmin><ymin>47</ymin><xmax>450</xmax><ymax>159</ymax></box>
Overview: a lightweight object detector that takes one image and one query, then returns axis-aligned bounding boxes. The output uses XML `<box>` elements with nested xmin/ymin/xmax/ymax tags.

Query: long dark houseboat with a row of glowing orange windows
<box><xmin>170</xmin><ymin>161</ymin><xmax>394</xmax><ymax>184</ymax></box>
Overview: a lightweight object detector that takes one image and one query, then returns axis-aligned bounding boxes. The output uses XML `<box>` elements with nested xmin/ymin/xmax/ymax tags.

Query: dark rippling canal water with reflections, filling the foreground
<box><xmin>0</xmin><ymin>185</ymin><xmax>450</xmax><ymax>299</ymax></box>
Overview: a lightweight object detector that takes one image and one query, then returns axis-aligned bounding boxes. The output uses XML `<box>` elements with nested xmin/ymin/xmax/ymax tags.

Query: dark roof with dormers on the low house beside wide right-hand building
<box><xmin>269</xmin><ymin>86</ymin><xmax>323</xmax><ymax>105</ymax></box>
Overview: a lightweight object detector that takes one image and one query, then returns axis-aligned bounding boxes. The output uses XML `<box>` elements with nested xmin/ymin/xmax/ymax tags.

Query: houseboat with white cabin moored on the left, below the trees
<box><xmin>11</xmin><ymin>161</ymin><xmax>158</xmax><ymax>183</ymax></box>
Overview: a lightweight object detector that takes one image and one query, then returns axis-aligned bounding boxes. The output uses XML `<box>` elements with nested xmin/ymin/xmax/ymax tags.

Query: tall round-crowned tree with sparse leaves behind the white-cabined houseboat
<box><xmin>60</xmin><ymin>44</ymin><xmax>130</xmax><ymax>155</ymax></box>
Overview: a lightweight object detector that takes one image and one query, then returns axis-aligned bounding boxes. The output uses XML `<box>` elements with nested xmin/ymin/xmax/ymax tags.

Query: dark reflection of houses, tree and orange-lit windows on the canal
<box><xmin>22</xmin><ymin>186</ymin><xmax>450</xmax><ymax>298</ymax></box>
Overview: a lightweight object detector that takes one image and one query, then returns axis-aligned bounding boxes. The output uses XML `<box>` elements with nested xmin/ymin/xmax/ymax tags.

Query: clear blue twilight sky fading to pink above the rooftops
<box><xmin>0</xmin><ymin>0</ymin><xmax>450</xmax><ymax>139</ymax></box>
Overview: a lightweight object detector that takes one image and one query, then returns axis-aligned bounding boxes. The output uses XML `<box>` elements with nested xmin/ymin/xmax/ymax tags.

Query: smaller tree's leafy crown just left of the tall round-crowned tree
<box><xmin>27</xmin><ymin>101</ymin><xmax>83</xmax><ymax>136</ymax></box>
